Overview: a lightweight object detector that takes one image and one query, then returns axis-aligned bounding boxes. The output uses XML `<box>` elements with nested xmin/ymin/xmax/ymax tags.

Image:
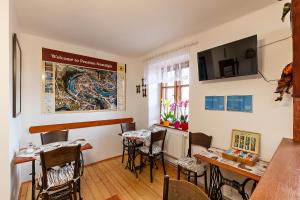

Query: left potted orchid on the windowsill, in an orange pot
<box><xmin>161</xmin><ymin>99</ymin><xmax>176</xmax><ymax>126</ymax></box>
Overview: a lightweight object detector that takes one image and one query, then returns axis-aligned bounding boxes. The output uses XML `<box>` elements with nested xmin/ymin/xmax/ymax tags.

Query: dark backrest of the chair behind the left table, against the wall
<box><xmin>41</xmin><ymin>130</ymin><xmax>69</xmax><ymax>145</ymax></box>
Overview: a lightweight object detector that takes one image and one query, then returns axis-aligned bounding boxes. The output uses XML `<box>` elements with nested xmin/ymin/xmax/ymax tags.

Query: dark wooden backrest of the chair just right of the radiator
<box><xmin>188</xmin><ymin>132</ymin><xmax>212</xmax><ymax>157</ymax></box>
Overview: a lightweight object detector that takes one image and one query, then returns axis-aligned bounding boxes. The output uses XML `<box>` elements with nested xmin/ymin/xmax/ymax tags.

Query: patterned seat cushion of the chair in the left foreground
<box><xmin>37</xmin><ymin>164</ymin><xmax>74</xmax><ymax>188</ymax></box>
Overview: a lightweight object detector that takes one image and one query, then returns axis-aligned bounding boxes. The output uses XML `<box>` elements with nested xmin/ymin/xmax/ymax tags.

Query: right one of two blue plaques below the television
<box><xmin>227</xmin><ymin>95</ymin><xmax>253</xmax><ymax>112</ymax></box>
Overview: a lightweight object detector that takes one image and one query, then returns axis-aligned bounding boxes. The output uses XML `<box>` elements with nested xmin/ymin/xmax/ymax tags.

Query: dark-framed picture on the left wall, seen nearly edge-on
<box><xmin>12</xmin><ymin>34</ymin><xmax>22</xmax><ymax>118</ymax></box>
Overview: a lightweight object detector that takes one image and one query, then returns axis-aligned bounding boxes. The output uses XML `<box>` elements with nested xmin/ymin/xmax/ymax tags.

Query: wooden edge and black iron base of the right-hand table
<box><xmin>194</xmin><ymin>149</ymin><xmax>268</xmax><ymax>200</ymax></box>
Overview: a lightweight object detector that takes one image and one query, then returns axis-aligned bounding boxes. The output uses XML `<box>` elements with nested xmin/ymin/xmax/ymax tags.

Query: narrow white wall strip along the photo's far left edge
<box><xmin>0</xmin><ymin>0</ymin><xmax>10</xmax><ymax>200</ymax></box>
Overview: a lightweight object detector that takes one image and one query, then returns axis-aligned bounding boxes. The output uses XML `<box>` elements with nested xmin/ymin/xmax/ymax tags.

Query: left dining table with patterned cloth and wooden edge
<box><xmin>14</xmin><ymin>139</ymin><xmax>93</xmax><ymax>200</ymax></box>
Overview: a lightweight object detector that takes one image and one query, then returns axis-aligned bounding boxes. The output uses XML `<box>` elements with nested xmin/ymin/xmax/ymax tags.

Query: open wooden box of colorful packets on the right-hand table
<box><xmin>222</xmin><ymin>129</ymin><xmax>260</xmax><ymax>166</ymax></box>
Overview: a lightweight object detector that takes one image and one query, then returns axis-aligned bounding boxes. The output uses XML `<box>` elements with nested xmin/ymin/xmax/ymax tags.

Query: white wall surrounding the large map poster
<box><xmin>19</xmin><ymin>34</ymin><xmax>146</xmax><ymax>181</ymax></box>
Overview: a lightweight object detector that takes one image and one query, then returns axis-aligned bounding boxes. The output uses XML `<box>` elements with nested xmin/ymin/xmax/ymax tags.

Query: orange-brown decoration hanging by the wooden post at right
<box><xmin>275</xmin><ymin>63</ymin><xmax>293</xmax><ymax>101</ymax></box>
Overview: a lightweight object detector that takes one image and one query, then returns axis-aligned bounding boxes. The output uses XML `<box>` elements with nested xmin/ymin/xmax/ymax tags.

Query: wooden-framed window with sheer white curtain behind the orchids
<box><xmin>160</xmin><ymin>61</ymin><xmax>189</xmax><ymax>121</ymax></box>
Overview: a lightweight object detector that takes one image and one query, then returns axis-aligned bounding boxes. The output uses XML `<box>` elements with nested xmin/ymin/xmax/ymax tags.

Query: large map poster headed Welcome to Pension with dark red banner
<box><xmin>42</xmin><ymin>48</ymin><xmax>126</xmax><ymax>113</ymax></box>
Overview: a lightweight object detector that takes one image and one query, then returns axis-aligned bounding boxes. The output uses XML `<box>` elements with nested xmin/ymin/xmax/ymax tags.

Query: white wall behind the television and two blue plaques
<box><xmin>145</xmin><ymin>3</ymin><xmax>292</xmax><ymax>196</ymax></box>
